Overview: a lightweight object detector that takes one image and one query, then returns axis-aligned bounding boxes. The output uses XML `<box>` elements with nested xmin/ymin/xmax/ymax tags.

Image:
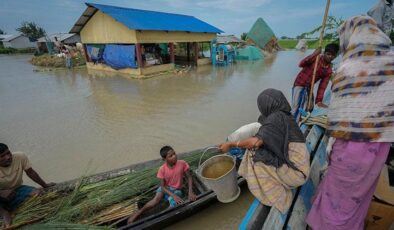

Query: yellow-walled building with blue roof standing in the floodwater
<box><xmin>70</xmin><ymin>3</ymin><xmax>223</xmax><ymax>75</ymax></box>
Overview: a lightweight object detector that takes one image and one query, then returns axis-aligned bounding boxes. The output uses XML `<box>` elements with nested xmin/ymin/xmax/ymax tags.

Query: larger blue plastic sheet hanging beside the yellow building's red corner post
<box><xmin>103</xmin><ymin>45</ymin><xmax>137</xmax><ymax>69</ymax></box>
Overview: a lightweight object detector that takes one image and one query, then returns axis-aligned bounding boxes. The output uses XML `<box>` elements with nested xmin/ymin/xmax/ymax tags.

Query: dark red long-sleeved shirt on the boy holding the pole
<box><xmin>294</xmin><ymin>55</ymin><xmax>332</xmax><ymax>104</ymax></box>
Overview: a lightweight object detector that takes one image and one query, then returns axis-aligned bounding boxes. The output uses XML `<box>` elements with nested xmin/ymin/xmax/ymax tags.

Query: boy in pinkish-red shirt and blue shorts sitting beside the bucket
<box><xmin>127</xmin><ymin>146</ymin><xmax>196</xmax><ymax>224</ymax></box>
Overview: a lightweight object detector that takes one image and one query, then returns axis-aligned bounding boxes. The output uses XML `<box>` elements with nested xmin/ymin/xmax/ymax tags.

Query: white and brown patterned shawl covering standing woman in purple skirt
<box><xmin>327</xmin><ymin>16</ymin><xmax>394</xmax><ymax>142</ymax></box>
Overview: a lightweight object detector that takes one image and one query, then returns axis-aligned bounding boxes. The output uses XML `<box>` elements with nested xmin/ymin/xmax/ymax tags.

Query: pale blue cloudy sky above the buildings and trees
<box><xmin>0</xmin><ymin>0</ymin><xmax>377</xmax><ymax>37</ymax></box>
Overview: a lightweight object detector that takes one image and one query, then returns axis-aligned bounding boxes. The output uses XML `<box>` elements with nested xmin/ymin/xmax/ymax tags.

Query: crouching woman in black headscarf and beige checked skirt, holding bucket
<box><xmin>219</xmin><ymin>89</ymin><xmax>310</xmax><ymax>213</ymax></box>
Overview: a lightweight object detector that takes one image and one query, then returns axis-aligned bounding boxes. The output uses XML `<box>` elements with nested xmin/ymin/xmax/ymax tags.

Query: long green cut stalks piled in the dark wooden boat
<box><xmin>3</xmin><ymin>148</ymin><xmax>217</xmax><ymax>228</ymax></box>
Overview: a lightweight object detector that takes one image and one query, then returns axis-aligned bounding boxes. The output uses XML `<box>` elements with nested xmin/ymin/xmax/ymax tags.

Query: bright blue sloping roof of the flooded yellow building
<box><xmin>70</xmin><ymin>3</ymin><xmax>223</xmax><ymax>33</ymax></box>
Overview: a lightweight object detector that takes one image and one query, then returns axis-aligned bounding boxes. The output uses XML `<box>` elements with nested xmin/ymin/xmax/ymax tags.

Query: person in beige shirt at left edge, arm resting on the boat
<box><xmin>0</xmin><ymin>143</ymin><xmax>55</xmax><ymax>227</ymax></box>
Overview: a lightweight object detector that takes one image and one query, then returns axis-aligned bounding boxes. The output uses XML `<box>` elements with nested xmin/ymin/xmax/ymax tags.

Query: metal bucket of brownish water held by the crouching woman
<box><xmin>198</xmin><ymin>155</ymin><xmax>241</xmax><ymax>203</ymax></box>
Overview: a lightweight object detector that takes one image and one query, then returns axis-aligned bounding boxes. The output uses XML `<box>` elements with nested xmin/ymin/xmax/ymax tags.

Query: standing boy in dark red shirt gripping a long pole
<box><xmin>291</xmin><ymin>43</ymin><xmax>339</xmax><ymax>122</ymax></box>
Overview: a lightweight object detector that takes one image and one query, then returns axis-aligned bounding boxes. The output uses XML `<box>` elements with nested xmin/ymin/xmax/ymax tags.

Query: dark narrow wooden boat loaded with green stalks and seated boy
<box><xmin>14</xmin><ymin>149</ymin><xmax>244</xmax><ymax>229</ymax></box>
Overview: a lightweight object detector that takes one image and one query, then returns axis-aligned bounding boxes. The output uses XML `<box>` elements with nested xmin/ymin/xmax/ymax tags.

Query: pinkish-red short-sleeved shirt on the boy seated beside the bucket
<box><xmin>157</xmin><ymin>160</ymin><xmax>190</xmax><ymax>189</ymax></box>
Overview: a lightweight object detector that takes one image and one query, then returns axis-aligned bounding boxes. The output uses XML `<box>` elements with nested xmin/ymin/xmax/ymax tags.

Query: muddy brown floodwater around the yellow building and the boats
<box><xmin>0</xmin><ymin>51</ymin><xmax>305</xmax><ymax>229</ymax></box>
